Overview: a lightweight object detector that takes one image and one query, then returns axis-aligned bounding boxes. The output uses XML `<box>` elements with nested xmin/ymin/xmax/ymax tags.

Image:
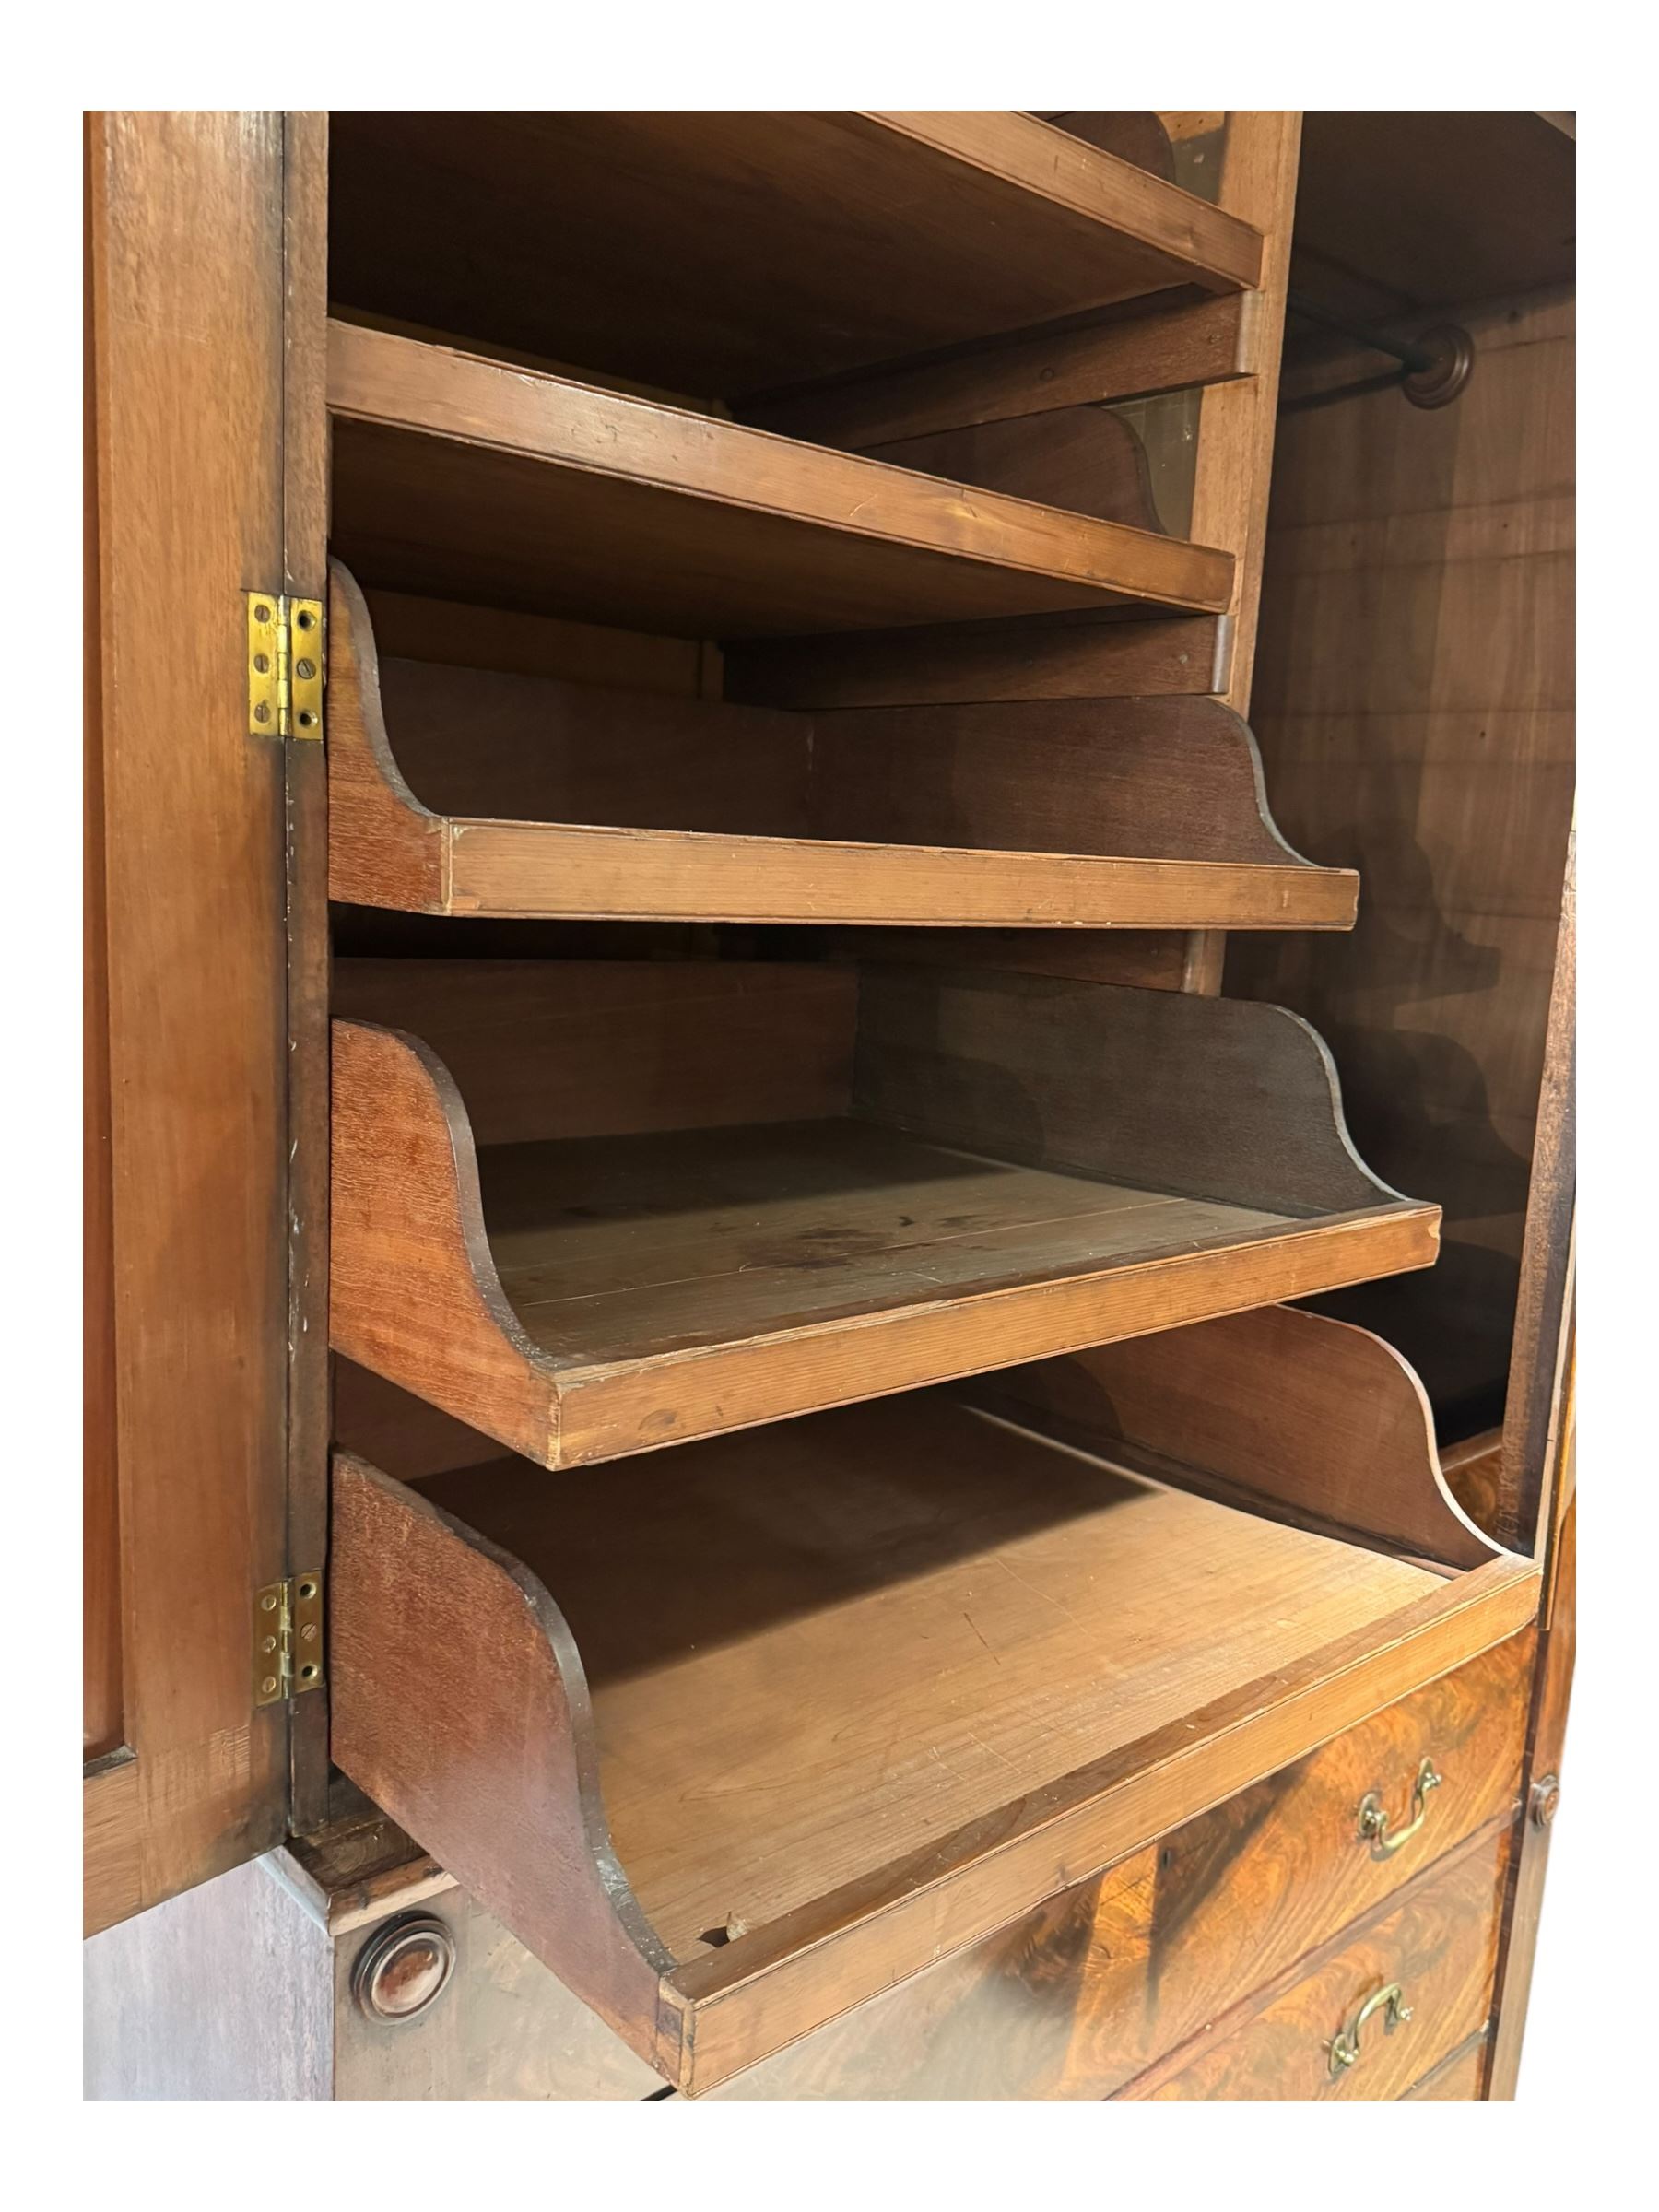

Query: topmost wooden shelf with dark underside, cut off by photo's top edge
<box><xmin>330</xmin><ymin>111</ymin><xmax>1261</xmax><ymax>398</ymax></box>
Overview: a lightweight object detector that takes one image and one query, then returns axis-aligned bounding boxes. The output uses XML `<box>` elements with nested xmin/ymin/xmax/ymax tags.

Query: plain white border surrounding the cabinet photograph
<box><xmin>19</xmin><ymin>13</ymin><xmax>1659</xmax><ymax>2212</ymax></box>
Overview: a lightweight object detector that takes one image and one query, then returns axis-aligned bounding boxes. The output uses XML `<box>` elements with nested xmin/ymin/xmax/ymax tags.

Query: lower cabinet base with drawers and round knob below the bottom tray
<box><xmin>77</xmin><ymin>1630</ymin><xmax>1535</xmax><ymax>2101</ymax></box>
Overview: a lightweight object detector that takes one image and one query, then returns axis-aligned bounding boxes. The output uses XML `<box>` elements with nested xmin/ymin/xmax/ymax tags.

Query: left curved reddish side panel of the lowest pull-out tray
<box><xmin>330</xmin><ymin>1453</ymin><xmax>684</xmax><ymax>2079</ymax></box>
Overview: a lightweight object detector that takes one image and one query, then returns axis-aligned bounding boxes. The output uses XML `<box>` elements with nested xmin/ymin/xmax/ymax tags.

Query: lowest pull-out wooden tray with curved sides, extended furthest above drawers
<box><xmin>330</xmin><ymin>1310</ymin><xmax>1537</xmax><ymax>2092</ymax></box>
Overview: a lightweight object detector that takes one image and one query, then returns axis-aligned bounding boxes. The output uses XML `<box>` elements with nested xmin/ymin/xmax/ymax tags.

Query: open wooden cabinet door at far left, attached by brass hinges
<box><xmin>84</xmin><ymin>112</ymin><xmax>305</xmax><ymax>1931</ymax></box>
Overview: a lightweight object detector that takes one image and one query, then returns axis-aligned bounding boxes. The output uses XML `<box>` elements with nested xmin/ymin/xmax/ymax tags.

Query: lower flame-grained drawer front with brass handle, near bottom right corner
<box><xmin>1128</xmin><ymin>1823</ymin><xmax>1513</xmax><ymax>2103</ymax></box>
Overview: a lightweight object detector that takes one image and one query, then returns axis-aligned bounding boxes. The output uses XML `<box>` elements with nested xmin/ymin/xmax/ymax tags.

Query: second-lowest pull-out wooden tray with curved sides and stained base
<box><xmin>330</xmin><ymin>960</ymin><xmax>1440</xmax><ymax>1480</ymax></box>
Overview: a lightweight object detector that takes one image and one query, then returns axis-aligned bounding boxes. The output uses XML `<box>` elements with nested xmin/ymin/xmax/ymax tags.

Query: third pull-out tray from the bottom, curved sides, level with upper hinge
<box><xmin>330</xmin><ymin>564</ymin><xmax>1359</xmax><ymax>929</ymax></box>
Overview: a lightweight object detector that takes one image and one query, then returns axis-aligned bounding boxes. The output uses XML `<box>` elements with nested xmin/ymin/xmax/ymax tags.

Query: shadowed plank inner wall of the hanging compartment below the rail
<box><xmin>1228</xmin><ymin>294</ymin><xmax>1575</xmax><ymax>1433</ymax></box>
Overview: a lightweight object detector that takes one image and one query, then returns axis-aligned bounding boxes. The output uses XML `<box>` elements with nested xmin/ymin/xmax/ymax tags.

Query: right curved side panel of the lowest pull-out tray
<box><xmin>973</xmin><ymin>1305</ymin><xmax>1513</xmax><ymax>1571</ymax></box>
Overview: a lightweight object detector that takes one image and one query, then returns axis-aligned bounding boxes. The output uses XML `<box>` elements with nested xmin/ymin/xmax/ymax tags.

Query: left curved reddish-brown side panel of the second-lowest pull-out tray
<box><xmin>330</xmin><ymin>1019</ymin><xmax>558</xmax><ymax>1465</ymax></box>
